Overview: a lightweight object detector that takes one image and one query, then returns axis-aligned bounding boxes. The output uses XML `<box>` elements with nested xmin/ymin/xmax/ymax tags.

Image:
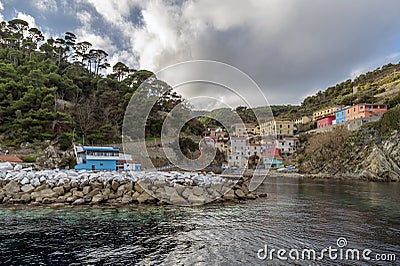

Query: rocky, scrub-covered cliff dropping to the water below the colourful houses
<box><xmin>298</xmin><ymin>123</ymin><xmax>400</xmax><ymax>182</ymax></box>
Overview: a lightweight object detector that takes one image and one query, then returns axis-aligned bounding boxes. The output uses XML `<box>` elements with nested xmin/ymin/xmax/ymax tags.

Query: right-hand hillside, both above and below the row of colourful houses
<box><xmin>297</xmin><ymin>64</ymin><xmax>400</xmax><ymax>181</ymax></box>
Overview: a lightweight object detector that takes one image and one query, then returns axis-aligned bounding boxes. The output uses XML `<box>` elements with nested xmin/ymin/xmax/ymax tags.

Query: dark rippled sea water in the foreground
<box><xmin>0</xmin><ymin>178</ymin><xmax>400</xmax><ymax>265</ymax></box>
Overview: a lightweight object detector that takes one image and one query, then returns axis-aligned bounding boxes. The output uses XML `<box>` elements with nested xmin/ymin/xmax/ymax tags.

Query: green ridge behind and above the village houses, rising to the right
<box><xmin>200</xmin><ymin>60</ymin><xmax>400</xmax><ymax>123</ymax></box>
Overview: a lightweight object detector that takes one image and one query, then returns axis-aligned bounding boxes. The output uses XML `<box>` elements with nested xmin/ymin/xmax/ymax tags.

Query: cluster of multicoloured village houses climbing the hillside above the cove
<box><xmin>206</xmin><ymin>104</ymin><xmax>388</xmax><ymax>169</ymax></box>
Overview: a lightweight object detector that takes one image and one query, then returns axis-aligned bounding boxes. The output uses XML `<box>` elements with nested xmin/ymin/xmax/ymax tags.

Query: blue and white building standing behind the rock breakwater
<box><xmin>75</xmin><ymin>146</ymin><xmax>140</xmax><ymax>171</ymax></box>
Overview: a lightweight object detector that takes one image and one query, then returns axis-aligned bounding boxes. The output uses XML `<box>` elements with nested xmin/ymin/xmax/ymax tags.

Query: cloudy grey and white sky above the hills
<box><xmin>0</xmin><ymin>0</ymin><xmax>400</xmax><ymax>104</ymax></box>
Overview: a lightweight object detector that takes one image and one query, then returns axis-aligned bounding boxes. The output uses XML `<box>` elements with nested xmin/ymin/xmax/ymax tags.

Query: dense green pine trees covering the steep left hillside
<box><xmin>0</xmin><ymin>19</ymin><xmax>182</xmax><ymax>149</ymax></box>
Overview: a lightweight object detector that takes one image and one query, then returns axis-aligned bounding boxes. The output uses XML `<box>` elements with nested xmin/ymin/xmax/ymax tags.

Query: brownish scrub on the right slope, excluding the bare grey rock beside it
<box><xmin>297</xmin><ymin>105</ymin><xmax>400</xmax><ymax>175</ymax></box>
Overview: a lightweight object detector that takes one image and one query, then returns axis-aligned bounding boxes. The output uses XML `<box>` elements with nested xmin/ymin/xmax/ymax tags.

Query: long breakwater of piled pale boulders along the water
<box><xmin>0</xmin><ymin>169</ymin><xmax>265</xmax><ymax>206</ymax></box>
